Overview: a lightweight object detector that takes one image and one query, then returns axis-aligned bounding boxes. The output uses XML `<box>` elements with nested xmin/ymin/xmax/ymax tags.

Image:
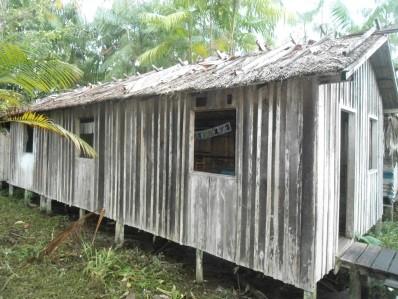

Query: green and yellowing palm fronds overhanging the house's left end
<box><xmin>0</xmin><ymin>42</ymin><xmax>96</xmax><ymax>157</ymax></box>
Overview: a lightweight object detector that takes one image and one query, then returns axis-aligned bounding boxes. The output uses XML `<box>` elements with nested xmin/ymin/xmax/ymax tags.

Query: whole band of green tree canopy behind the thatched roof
<box><xmin>0</xmin><ymin>0</ymin><xmax>398</xmax><ymax>84</ymax></box>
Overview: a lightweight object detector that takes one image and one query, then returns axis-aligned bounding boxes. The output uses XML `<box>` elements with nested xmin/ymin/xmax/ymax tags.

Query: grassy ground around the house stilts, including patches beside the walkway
<box><xmin>0</xmin><ymin>191</ymin><xmax>398</xmax><ymax>299</ymax></box>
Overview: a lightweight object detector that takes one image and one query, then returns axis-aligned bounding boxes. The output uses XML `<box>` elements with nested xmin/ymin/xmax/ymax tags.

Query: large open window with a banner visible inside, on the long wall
<box><xmin>194</xmin><ymin>110</ymin><xmax>236</xmax><ymax>175</ymax></box>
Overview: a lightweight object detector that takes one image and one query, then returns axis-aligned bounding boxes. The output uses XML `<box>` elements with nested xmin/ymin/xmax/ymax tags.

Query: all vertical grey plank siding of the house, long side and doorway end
<box><xmin>5</xmin><ymin>71</ymin><xmax>383</xmax><ymax>290</ymax></box>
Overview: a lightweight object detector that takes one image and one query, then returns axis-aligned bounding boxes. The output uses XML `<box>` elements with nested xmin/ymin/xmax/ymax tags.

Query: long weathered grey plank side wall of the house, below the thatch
<box><xmin>7</xmin><ymin>78</ymin><xmax>317</xmax><ymax>289</ymax></box>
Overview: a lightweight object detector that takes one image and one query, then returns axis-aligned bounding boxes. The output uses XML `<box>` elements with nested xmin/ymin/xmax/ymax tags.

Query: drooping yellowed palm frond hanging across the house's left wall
<box><xmin>0</xmin><ymin>112</ymin><xmax>97</xmax><ymax>158</ymax></box>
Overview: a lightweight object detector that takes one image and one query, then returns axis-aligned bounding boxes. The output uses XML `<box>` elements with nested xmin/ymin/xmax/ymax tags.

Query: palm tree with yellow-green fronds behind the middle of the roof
<box><xmin>138</xmin><ymin>0</ymin><xmax>284</xmax><ymax>63</ymax></box>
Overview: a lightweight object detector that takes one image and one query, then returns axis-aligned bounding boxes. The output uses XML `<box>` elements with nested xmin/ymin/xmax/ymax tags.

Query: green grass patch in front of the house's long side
<box><xmin>0</xmin><ymin>191</ymin><xmax>235</xmax><ymax>299</ymax></box>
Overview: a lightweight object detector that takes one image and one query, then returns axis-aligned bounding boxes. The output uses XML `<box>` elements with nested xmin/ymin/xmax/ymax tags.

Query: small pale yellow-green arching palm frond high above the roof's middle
<box><xmin>140</xmin><ymin>11</ymin><xmax>189</xmax><ymax>31</ymax></box>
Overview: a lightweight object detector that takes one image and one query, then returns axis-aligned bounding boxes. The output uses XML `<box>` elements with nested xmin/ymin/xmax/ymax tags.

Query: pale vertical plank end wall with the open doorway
<box><xmin>316</xmin><ymin>62</ymin><xmax>384</xmax><ymax>280</ymax></box>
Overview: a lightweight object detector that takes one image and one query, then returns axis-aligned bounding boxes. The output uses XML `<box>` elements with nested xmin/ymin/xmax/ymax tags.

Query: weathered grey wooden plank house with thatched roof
<box><xmin>0</xmin><ymin>31</ymin><xmax>398</xmax><ymax>292</ymax></box>
